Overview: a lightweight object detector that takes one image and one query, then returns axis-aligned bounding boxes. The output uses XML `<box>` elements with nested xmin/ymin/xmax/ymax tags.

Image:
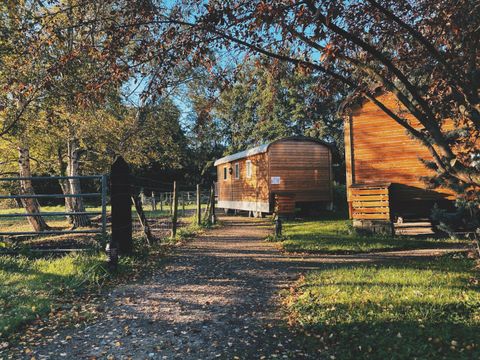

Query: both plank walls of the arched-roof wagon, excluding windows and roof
<box><xmin>217</xmin><ymin>138</ymin><xmax>333</xmax><ymax>212</ymax></box>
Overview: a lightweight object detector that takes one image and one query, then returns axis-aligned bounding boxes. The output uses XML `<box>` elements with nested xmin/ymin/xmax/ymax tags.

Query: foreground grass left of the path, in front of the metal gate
<box><xmin>0</xmin><ymin>239</ymin><xmax>167</xmax><ymax>339</ymax></box>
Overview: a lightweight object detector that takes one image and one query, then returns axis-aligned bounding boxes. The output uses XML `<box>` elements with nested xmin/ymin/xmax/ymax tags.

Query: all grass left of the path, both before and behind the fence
<box><xmin>0</xmin><ymin>198</ymin><xmax>206</xmax><ymax>339</ymax></box>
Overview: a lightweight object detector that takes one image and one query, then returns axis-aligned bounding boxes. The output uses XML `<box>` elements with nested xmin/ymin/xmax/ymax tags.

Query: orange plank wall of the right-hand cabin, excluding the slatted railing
<box><xmin>345</xmin><ymin>94</ymin><xmax>451</xmax><ymax>215</ymax></box>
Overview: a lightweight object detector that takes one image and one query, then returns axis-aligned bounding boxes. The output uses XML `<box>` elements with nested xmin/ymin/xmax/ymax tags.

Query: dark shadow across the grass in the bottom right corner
<box><xmin>296</xmin><ymin>321</ymin><xmax>480</xmax><ymax>360</ymax></box>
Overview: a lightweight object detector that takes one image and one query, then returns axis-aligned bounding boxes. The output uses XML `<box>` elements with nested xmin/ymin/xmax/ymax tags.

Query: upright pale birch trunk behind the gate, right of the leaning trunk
<box><xmin>66</xmin><ymin>138</ymin><xmax>91</xmax><ymax>228</ymax></box>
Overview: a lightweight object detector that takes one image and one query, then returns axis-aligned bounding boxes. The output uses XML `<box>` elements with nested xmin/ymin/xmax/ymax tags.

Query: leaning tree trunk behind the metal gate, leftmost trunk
<box><xmin>18</xmin><ymin>145</ymin><xmax>49</xmax><ymax>231</ymax></box>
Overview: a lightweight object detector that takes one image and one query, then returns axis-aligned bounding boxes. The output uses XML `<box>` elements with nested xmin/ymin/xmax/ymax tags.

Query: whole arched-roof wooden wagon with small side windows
<box><xmin>215</xmin><ymin>137</ymin><xmax>333</xmax><ymax>216</ymax></box>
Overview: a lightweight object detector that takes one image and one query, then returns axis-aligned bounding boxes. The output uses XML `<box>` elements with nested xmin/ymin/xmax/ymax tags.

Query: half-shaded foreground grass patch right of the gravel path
<box><xmin>285</xmin><ymin>255</ymin><xmax>480</xmax><ymax>359</ymax></box>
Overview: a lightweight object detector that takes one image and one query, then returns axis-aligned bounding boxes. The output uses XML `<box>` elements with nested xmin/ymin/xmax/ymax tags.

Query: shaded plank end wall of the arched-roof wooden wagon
<box><xmin>268</xmin><ymin>139</ymin><xmax>333</xmax><ymax>202</ymax></box>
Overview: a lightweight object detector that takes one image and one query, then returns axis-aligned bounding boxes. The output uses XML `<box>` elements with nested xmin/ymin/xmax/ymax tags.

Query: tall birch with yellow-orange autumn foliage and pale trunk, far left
<box><xmin>0</xmin><ymin>0</ymin><xmax>155</xmax><ymax>227</ymax></box>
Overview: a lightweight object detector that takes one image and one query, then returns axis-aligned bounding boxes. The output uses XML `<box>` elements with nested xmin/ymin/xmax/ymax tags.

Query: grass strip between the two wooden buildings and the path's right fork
<box><xmin>279</xmin><ymin>219</ymin><xmax>466</xmax><ymax>254</ymax></box>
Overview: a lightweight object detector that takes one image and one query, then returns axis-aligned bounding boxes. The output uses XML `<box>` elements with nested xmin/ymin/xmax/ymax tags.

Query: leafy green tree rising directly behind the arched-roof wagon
<box><xmin>213</xmin><ymin>57</ymin><xmax>343</xmax><ymax>153</ymax></box>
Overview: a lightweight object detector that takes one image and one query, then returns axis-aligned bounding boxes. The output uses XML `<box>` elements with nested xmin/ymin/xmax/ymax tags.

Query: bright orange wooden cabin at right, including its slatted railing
<box><xmin>345</xmin><ymin>93</ymin><xmax>453</xmax><ymax>232</ymax></box>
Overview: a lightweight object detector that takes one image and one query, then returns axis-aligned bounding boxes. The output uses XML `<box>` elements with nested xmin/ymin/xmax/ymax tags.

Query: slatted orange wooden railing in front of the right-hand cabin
<box><xmin>350</xmin><ymin>184</ymin><xmax>390</xmax><ymax>221</ymax></box>
